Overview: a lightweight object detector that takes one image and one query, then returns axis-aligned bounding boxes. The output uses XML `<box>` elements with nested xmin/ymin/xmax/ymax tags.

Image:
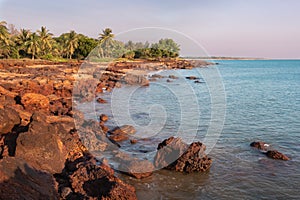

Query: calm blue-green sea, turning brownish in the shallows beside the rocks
<box><xmin>78</xmin><ymin>60</ymin><xmax>300</xmax><ymax>199</ymax></box>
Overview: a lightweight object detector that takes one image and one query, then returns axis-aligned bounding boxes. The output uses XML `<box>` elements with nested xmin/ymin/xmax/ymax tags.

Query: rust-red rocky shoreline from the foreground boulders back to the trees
<box><xmin>0</xmin><ymin>60</ymin><xmax>211</xmax><ymax>199</ymax></box>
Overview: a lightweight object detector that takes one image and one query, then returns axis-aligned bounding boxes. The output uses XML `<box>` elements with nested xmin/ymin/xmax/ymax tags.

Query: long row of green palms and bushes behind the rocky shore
<box><xmin>0</xmin><ymin>21</ymin><xmax>180</xmax><ymax>60</ymax></box>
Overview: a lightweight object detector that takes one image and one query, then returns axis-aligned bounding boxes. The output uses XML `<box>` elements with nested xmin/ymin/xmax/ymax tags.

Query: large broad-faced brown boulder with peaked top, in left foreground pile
<box><xmin>15</xmin><ymin>112</ymin><xmax>67</xmax><ymax>173</ymax></box>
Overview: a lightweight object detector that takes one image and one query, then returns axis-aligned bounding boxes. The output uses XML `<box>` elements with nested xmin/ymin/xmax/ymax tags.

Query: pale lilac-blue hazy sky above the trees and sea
<box><xmin>0</xmin><ymin>0</ymin><xmax>300</xmax><ymax>59</ymax></box>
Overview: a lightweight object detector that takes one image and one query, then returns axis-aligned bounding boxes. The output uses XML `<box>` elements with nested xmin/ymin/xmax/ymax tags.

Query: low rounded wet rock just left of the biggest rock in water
<box><xmin>120</xmin><ymin>160</ymin><xmax>154</xmax><ymax>179</ymax></box>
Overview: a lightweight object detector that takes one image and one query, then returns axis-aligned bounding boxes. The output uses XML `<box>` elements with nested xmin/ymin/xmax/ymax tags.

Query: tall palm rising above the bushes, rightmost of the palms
<box><xmin>99</xmin><ymin>28</ymin><xmax>115</xmax><ymax>57</ymax></box>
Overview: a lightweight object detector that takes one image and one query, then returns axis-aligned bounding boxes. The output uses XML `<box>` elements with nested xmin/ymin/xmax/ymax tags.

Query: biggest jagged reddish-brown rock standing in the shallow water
<box><xmin>154</xmin><ymin>137</ymin><xmax>212</xmax><ymax>173</ymax></box>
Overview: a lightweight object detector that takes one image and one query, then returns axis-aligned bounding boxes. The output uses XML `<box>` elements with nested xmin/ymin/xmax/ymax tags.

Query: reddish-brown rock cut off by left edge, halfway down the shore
<box><xmin>0</xmin><ymin>108</ymin><xmax>21</xmax><ymax>134</ymax></box>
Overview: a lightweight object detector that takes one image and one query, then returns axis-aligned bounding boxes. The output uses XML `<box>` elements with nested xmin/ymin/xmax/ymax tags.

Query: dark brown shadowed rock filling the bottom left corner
<box><xmin>0</xmin><ymin>157</ymin><xmax>58</xmax><ymax>199</ymax></box>
